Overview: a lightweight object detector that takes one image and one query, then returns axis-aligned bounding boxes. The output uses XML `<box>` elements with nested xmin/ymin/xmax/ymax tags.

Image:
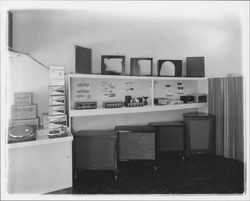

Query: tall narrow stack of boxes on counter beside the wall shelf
<box><xmin>46</xmin><ymin>66</ymin><xmax>67</xmax><ymax>130</ymax></box>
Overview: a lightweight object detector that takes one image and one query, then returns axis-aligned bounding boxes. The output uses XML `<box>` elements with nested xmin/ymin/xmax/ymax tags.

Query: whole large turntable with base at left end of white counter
<box><xmin>8</xmin><ymin>125</ymin><xmax>36</xmax><ymax>143</ymax></box>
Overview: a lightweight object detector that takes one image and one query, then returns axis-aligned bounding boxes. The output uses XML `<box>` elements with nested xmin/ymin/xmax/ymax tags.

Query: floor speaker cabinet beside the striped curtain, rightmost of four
<box><xmin>183</xmin><ymin>113</ymin><xmax>215</xmax><ymax>156</ymax></box>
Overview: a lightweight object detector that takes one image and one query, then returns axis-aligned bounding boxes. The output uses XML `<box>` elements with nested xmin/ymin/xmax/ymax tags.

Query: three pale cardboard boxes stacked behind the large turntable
<box><xmin>9</xmin><ymin>92</ymin><xmax>39</xmax><ymax>128</ymax></box>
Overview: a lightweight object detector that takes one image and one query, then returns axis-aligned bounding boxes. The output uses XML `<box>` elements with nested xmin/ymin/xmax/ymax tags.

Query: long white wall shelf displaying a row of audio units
<box><xmin>68</xmin><ymin>74</ymin><xmax>208</xmax><ymax>128</ymax></box>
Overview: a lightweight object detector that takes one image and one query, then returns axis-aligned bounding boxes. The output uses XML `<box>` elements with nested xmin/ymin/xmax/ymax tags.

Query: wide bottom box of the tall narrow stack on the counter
<box><xmin>43</xmin><ymin>115</ymin><xmax>67</xmax><ymax>129</ymax></box>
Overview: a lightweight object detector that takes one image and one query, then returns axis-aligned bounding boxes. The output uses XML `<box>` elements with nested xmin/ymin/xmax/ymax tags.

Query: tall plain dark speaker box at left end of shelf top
<box><xmin>75</xmin><ymin>45</ymin><xmax>92</xmax><ymax>74</ymax></box>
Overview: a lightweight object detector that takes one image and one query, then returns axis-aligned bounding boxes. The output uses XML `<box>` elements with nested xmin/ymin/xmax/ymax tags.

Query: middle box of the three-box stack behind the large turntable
<box><xmin>11</xmin><ymin>105</ymin><xmax>37</xmax><ymax>119</ymax></box>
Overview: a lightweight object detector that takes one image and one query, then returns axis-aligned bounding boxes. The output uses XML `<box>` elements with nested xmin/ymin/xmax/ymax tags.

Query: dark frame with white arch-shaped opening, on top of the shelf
<box><xmin>157</xmin><ymin>59</ymin><xmax>182</xmax><ymax>77</ymax></box>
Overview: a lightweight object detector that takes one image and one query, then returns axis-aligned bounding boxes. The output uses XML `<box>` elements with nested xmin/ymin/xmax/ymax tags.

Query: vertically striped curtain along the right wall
<box><xmin>208</xmin><ymin>77</ymin><xmax>244</xmax><ymax>161</ymax></box>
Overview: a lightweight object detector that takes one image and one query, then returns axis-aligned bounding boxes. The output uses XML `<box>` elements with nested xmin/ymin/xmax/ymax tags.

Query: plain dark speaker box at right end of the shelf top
<box><xmin>186</xmin><ymin>57</ymin><xmax>205</xmax><ymax>77</ymax></box>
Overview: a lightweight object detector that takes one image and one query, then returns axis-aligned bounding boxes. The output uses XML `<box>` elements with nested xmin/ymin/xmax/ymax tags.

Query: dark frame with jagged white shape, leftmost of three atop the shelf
<box><xmin>101</xmin><ymin>55</ymin><xmax>125</xmax><ymax>75</ymax></box>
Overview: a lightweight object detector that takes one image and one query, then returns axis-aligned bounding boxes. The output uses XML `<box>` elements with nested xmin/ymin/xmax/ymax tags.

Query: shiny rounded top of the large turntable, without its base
<box><xmin>9</xmin><ymin>125</ymin><xmax>33</xmax><ymax>138</ymax></box>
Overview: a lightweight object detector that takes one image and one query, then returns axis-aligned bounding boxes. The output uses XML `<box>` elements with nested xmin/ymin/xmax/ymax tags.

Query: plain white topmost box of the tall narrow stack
<box><xmin>50</xmin><ymin>66</ymin><xmax>64</xmax><ymax>85</ymax></box>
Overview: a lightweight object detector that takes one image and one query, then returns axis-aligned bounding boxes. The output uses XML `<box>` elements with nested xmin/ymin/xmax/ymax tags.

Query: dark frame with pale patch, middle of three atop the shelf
<box><xmin>130</xmin><ymin>58</ymin><xmax>153</xmax><ymax>76</ymax></box>
